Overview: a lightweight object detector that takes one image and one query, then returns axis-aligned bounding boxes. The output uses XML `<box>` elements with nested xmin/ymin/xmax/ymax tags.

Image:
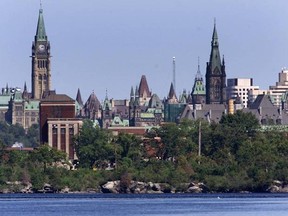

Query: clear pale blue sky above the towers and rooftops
<box><xmin>0</xmin><ymin>0</ymin><xmax>288</xmax><ymax>102</ymax></box>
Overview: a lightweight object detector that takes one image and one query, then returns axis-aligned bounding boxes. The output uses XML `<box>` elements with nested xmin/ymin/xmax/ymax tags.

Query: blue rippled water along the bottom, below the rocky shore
<box><xmin>0</xmin><ymin>194</ymin><xmax>288</xmax><ymax>216</ymax></box>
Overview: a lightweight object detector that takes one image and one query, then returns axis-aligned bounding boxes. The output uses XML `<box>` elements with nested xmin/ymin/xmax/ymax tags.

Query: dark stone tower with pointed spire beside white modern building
<box><xmin>206</xmin><ymin>22</ymin><xmax>226</xmax><ymax>104</ymax></box>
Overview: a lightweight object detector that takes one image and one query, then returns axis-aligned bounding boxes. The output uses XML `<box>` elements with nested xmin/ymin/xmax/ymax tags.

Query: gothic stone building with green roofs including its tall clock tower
<box><xmin>0</xmin><ymin>9</ymin><xmax>51</xmax><ymax>130</ymax></box>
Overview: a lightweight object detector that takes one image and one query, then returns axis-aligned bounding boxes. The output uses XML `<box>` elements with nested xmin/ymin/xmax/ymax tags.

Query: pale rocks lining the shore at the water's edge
<box><xmin>0</xmin><ymin>180</ymin><xmax>288</xmax><ymax>194</ymax></box>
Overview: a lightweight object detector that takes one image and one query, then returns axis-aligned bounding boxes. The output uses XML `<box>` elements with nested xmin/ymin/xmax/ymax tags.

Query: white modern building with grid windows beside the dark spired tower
<box><xmin>226</xmin><ymin>78</ymin><xmax>259</xmax><ymax>108</ymax></box>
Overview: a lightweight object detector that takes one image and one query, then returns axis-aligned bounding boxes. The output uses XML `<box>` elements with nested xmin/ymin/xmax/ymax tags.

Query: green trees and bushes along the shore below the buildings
<box><xmin>0</xmin><ymin>111</ymin><xmax>288</xmax><ymax>192</ymax></box>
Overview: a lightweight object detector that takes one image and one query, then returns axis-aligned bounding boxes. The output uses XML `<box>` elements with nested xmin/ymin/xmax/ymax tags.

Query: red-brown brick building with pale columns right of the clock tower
<box><xmin>39</xmin><ymin>92</ymin><xmax>82</xmax><ymax>160</ymax></box>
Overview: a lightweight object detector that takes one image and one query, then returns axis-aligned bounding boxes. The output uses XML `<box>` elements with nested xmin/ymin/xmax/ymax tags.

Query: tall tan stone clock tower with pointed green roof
<box><xmin>31</xmin><ymin>8</ymin><xmax>51</xmax><ymax>99</ymax></box>
